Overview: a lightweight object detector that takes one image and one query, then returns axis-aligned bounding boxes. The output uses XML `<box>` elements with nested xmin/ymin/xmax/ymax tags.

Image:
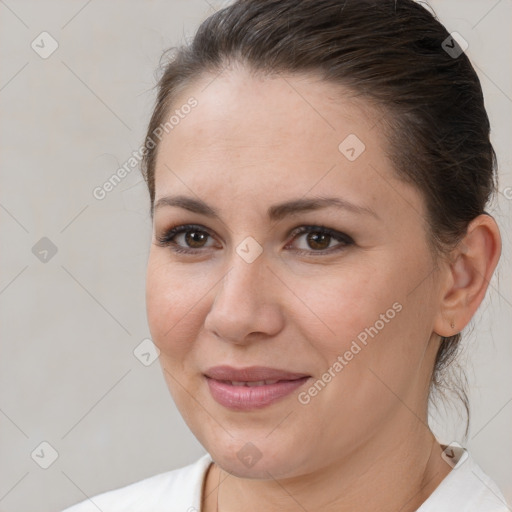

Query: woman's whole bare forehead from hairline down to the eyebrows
<box><xmin>155</xmin><ymin>69</ymin><xmax>420</xmax><ymax>222</ymax></box>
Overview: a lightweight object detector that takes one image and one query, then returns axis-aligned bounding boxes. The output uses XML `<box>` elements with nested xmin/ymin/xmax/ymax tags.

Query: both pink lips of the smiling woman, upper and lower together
<box><xmin>204</xmin><ymin>366</ymin><xmax>310</xmax><ymax>411</ymax></box>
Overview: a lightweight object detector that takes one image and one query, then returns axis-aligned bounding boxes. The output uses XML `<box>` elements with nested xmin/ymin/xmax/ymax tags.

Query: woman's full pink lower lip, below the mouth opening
<box><xmin>206</xmin><ymin>377</ymin><xmax>309</xmax><ymax>411</ymax></box>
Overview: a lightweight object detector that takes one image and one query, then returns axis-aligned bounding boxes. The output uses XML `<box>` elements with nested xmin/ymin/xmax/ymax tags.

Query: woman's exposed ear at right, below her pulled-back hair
<box><xmin>434</xmin><ymin>214</ymin><xmax>501</xmax><ymax>337</ymax></box>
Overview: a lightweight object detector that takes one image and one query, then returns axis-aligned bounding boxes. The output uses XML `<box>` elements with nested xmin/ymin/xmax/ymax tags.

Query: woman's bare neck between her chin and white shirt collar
<box><xmin>203</xmin><ymin>419</ymin><xmax>450</xmax><ymax>512</ymax></box>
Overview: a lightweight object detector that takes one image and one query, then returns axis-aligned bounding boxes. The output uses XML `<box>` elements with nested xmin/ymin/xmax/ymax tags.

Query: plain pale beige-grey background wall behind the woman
<box><xmin>0</xmin><ymin>0</ymin><xmax>512</xmax><ymax>512</ymax></box>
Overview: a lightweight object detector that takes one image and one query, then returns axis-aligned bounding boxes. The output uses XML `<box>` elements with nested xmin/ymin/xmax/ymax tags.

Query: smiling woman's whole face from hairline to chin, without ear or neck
<box><xmin>147</xmin><ymin>69</ymin><xmax>441</xmax><ymax>478</ymax></box>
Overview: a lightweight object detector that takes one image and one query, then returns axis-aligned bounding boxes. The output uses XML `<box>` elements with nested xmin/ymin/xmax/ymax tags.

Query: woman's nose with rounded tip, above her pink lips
<box><xmin>204</xmin><ymin>252</ymin><xmax>284</xmax><ymax>344</ymax></box>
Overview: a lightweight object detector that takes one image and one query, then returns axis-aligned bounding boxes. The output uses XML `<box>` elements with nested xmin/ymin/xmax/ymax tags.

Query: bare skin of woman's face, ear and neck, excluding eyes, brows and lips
<box><xmin>146</xmin><ymin>67</ymin><xmax>500</xmax><ymax>512</ymax></box>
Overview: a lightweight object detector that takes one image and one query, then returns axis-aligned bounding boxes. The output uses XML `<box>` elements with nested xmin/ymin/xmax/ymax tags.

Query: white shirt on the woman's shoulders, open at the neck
<box><xmin>63</xmin><ymin>449</ymin><xmax>512</xmax><ymax>512</ymax></box>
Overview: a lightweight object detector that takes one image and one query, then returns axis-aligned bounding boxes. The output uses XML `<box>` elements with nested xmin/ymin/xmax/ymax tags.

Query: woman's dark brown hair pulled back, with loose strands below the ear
<box><xmin>143</xmin><ymin>0</ymin><xmax>496</xmax><ymax>434</ymax></box>
